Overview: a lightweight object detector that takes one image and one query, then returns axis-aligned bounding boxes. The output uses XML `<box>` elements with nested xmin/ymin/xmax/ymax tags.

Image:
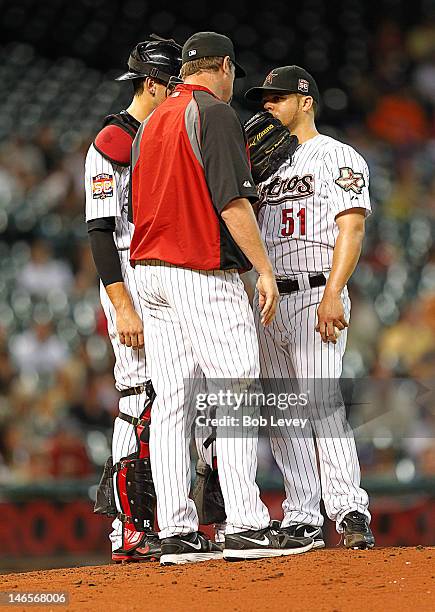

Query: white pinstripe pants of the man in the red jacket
<box><xmin>135</xmin><ymin>261</ymin><xmax>269</xmax><ymax>538</ymax></box>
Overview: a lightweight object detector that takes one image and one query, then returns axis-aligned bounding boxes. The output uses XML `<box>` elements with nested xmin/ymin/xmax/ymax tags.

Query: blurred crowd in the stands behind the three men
<box><xmin>0</xmin><ymin>7</ymin><xmax>435</xmax><ymax>484</ymax></box>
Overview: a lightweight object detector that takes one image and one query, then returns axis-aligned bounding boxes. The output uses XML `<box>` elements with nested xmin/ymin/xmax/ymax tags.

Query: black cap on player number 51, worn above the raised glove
<box><xmin>245</xmin><ymin>66</ymin><xmax>320</xmax><ymax>103</ymax></box>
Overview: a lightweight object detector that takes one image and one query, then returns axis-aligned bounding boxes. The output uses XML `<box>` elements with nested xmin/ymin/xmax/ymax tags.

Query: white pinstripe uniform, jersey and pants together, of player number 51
<box><xmin>255</xmin><ymin>134</ymin><xmax>370</xmax><ymax>531</ymax></box>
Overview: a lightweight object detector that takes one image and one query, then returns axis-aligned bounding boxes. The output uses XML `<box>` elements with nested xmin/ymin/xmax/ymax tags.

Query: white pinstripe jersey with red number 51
<box><xmin>258</xmin><ymin>134</ymin><xmax>371</xmax><ymax>278</ymax></box>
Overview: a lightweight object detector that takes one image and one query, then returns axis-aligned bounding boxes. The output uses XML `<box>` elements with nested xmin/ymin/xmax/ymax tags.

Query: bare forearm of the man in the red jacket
<box><xmin>221</xmin><ymin>198</ymin><xmax>272</xmax><ymax>274</ymax></box>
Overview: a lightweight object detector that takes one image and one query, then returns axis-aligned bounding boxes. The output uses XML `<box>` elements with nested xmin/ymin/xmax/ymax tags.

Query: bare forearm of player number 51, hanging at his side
<box><xmin>325</xmin><ymin>227</ymin><xmax>364</xmax><ymax>294</ymax></box>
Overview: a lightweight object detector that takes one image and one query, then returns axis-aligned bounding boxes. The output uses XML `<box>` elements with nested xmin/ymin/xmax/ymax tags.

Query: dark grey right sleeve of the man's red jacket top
<box><xmin>199</xmin><ymin>101</ymin><xmax>258</xmax><ymax>212</ymax></box>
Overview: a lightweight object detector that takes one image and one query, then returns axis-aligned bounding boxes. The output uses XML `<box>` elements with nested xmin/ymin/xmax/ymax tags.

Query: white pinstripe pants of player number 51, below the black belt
<box><xmin>254</xmin><ymin>280</ymin><xmax>370</xmax><ymax>531</ymax></box>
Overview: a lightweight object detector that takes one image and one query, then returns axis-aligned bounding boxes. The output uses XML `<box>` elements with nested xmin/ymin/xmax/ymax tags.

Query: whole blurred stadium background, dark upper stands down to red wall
<box><xmin>0</xmin><ymin>0</ymin><xmax>435</xmax><ymax>569</ymax></box>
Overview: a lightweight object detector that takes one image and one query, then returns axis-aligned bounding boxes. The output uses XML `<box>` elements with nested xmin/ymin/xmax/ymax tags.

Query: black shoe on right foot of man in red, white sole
<box><xmin>224</xmin><ymin>527</ymin><xmax>314</xmax><ymax>561</ymax></box>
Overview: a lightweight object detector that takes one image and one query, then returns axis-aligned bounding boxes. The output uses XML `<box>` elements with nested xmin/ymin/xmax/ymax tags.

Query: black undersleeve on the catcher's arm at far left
<box><xmin>87</xmin><ymin>217</ymin><xmax>124</xmax><ymax>287</ymax></box>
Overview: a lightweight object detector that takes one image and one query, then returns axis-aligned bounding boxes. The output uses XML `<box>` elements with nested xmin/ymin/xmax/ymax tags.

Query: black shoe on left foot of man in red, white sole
<box><xmin>160</xmin><ymin>531</ymin><xmax>222</xmax><ymax>565</ymax></box>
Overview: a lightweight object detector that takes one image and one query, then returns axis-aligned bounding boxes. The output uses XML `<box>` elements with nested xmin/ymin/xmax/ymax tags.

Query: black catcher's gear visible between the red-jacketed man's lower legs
<box><xmin>192</xmin><ymin>459</ymin><xmax>227</xmax><ymax>525</ymax></box>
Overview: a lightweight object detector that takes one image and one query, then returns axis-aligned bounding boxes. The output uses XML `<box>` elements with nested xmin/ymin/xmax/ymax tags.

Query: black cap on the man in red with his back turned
<box><xmin>182</xmin><ymin>32</ymin><xmax>246</xmax><ymax>78</ymax></box>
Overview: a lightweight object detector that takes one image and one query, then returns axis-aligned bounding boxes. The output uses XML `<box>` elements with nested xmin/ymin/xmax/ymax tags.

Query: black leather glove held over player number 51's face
<box><xmin>245</xmin><ymin>111</ymin><xmax>299</xmax><ymax>185</ymax></box>
